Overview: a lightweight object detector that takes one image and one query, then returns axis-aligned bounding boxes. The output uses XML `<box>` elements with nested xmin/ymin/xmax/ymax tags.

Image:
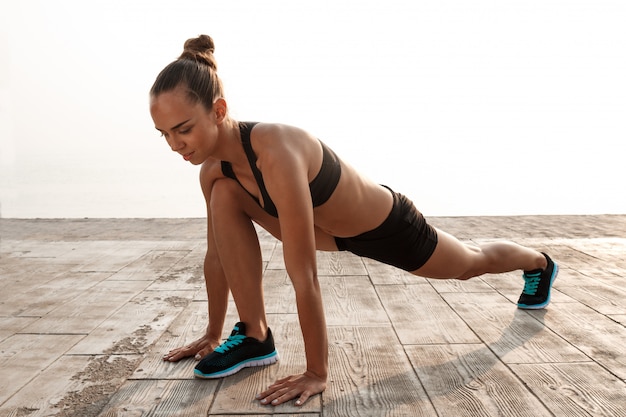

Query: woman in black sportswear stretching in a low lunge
<box><xmin>150</xmin><ymin>35</ymin><xmax>558</xmax><ymax>405</ymax></box>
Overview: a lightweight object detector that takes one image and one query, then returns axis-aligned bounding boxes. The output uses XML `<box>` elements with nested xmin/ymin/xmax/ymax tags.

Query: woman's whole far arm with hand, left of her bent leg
<box><xmin>163</xmin><ymin>162</ymin><xmax>229</xmax><ymax>362</ymax></box>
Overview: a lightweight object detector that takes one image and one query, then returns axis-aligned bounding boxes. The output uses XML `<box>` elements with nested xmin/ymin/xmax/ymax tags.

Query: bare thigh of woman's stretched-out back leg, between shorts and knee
<box><xmin>412</xmin><ymin>229</ymin><xmax>481</xmax><ymax>279</ymax></box>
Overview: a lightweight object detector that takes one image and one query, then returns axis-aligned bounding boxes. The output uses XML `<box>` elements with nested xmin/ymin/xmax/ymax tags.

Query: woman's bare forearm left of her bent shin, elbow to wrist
<box><xmin>204</xmin><ymin>252</ymin><xmax>229</xmax><ymax>340</ymax></box>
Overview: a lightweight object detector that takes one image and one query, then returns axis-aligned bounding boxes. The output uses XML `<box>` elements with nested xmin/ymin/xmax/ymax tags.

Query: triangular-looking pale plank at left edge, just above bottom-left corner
<box><xmin>0</xmin><ymin>334</ymin><xmax>82</xmax><ymax>404</ymax></box>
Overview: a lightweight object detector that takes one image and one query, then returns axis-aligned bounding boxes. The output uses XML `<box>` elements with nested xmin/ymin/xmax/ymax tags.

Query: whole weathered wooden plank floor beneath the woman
<box><xmin>0</xmin><ymin>215</ymin><xmax>626</xmax><ymax>417</ymax></box>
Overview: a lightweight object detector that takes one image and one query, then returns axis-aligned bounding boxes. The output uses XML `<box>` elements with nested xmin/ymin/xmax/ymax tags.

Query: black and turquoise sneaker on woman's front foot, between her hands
<box><xmin>193</xmin><ymin>322</ymin><xmax>278</xmax><ymax>379</ymax></box>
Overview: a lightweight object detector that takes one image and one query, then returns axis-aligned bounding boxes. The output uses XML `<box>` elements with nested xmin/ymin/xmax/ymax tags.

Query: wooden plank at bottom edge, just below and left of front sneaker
<box><xmin>94</xmin><ymin>379</ymin><xmax>219</xmax><ymax>417</ymax></box>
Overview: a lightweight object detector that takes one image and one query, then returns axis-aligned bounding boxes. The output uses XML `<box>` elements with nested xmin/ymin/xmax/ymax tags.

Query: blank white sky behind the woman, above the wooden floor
<box><xmin>0</xmin><ymin>0</ymin><xmax>626</xmax><ymax>217</ymax></box>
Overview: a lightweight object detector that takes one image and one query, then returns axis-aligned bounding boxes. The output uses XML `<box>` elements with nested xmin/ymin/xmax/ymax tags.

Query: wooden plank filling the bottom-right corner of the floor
<box><xmin>511</xmin><ymin>363</ymin><xmax>626</xmax><ymax>417</ymax></box>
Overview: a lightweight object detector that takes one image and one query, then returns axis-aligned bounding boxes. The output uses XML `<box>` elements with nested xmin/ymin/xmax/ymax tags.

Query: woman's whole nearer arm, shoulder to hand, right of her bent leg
<box><xmin>254</xmin><ymin>129</ymin><xmax>328</xmax><ymax>405</ymax></box>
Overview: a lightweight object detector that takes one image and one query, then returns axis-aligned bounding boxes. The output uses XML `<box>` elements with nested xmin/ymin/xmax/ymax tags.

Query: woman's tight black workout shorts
<box><xmin>335</xmin><ymin>189</ymin><xmax>437</xmax><ymax>271</ymax></box>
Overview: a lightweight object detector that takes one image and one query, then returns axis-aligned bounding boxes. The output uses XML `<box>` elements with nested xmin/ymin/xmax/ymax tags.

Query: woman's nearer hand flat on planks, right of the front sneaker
<box><xmin>256</xmin><ymin>371</ymin><xmax>326</xmax><ymax>406</ymax></box>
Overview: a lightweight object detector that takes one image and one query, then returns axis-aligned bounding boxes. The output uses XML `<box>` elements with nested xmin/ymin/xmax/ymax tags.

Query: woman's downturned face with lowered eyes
<box><xmin>150</xmin><ymin>89</ymin><xmax>218</xmax><ymax>165</ymax></box>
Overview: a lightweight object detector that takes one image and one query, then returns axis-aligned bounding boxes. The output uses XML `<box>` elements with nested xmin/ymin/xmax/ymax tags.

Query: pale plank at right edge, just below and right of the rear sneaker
<box><xmin>544</xmin><ymin>303</ymin><xmax>626</xmax><ymax>379</ymax></box>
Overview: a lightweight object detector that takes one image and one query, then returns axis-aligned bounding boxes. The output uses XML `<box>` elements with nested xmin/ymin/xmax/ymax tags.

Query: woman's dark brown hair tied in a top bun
<box><xmin>150</xmin><ymin>35</ymin><xmax>224</xmax><ymax>110</ymax></box>
